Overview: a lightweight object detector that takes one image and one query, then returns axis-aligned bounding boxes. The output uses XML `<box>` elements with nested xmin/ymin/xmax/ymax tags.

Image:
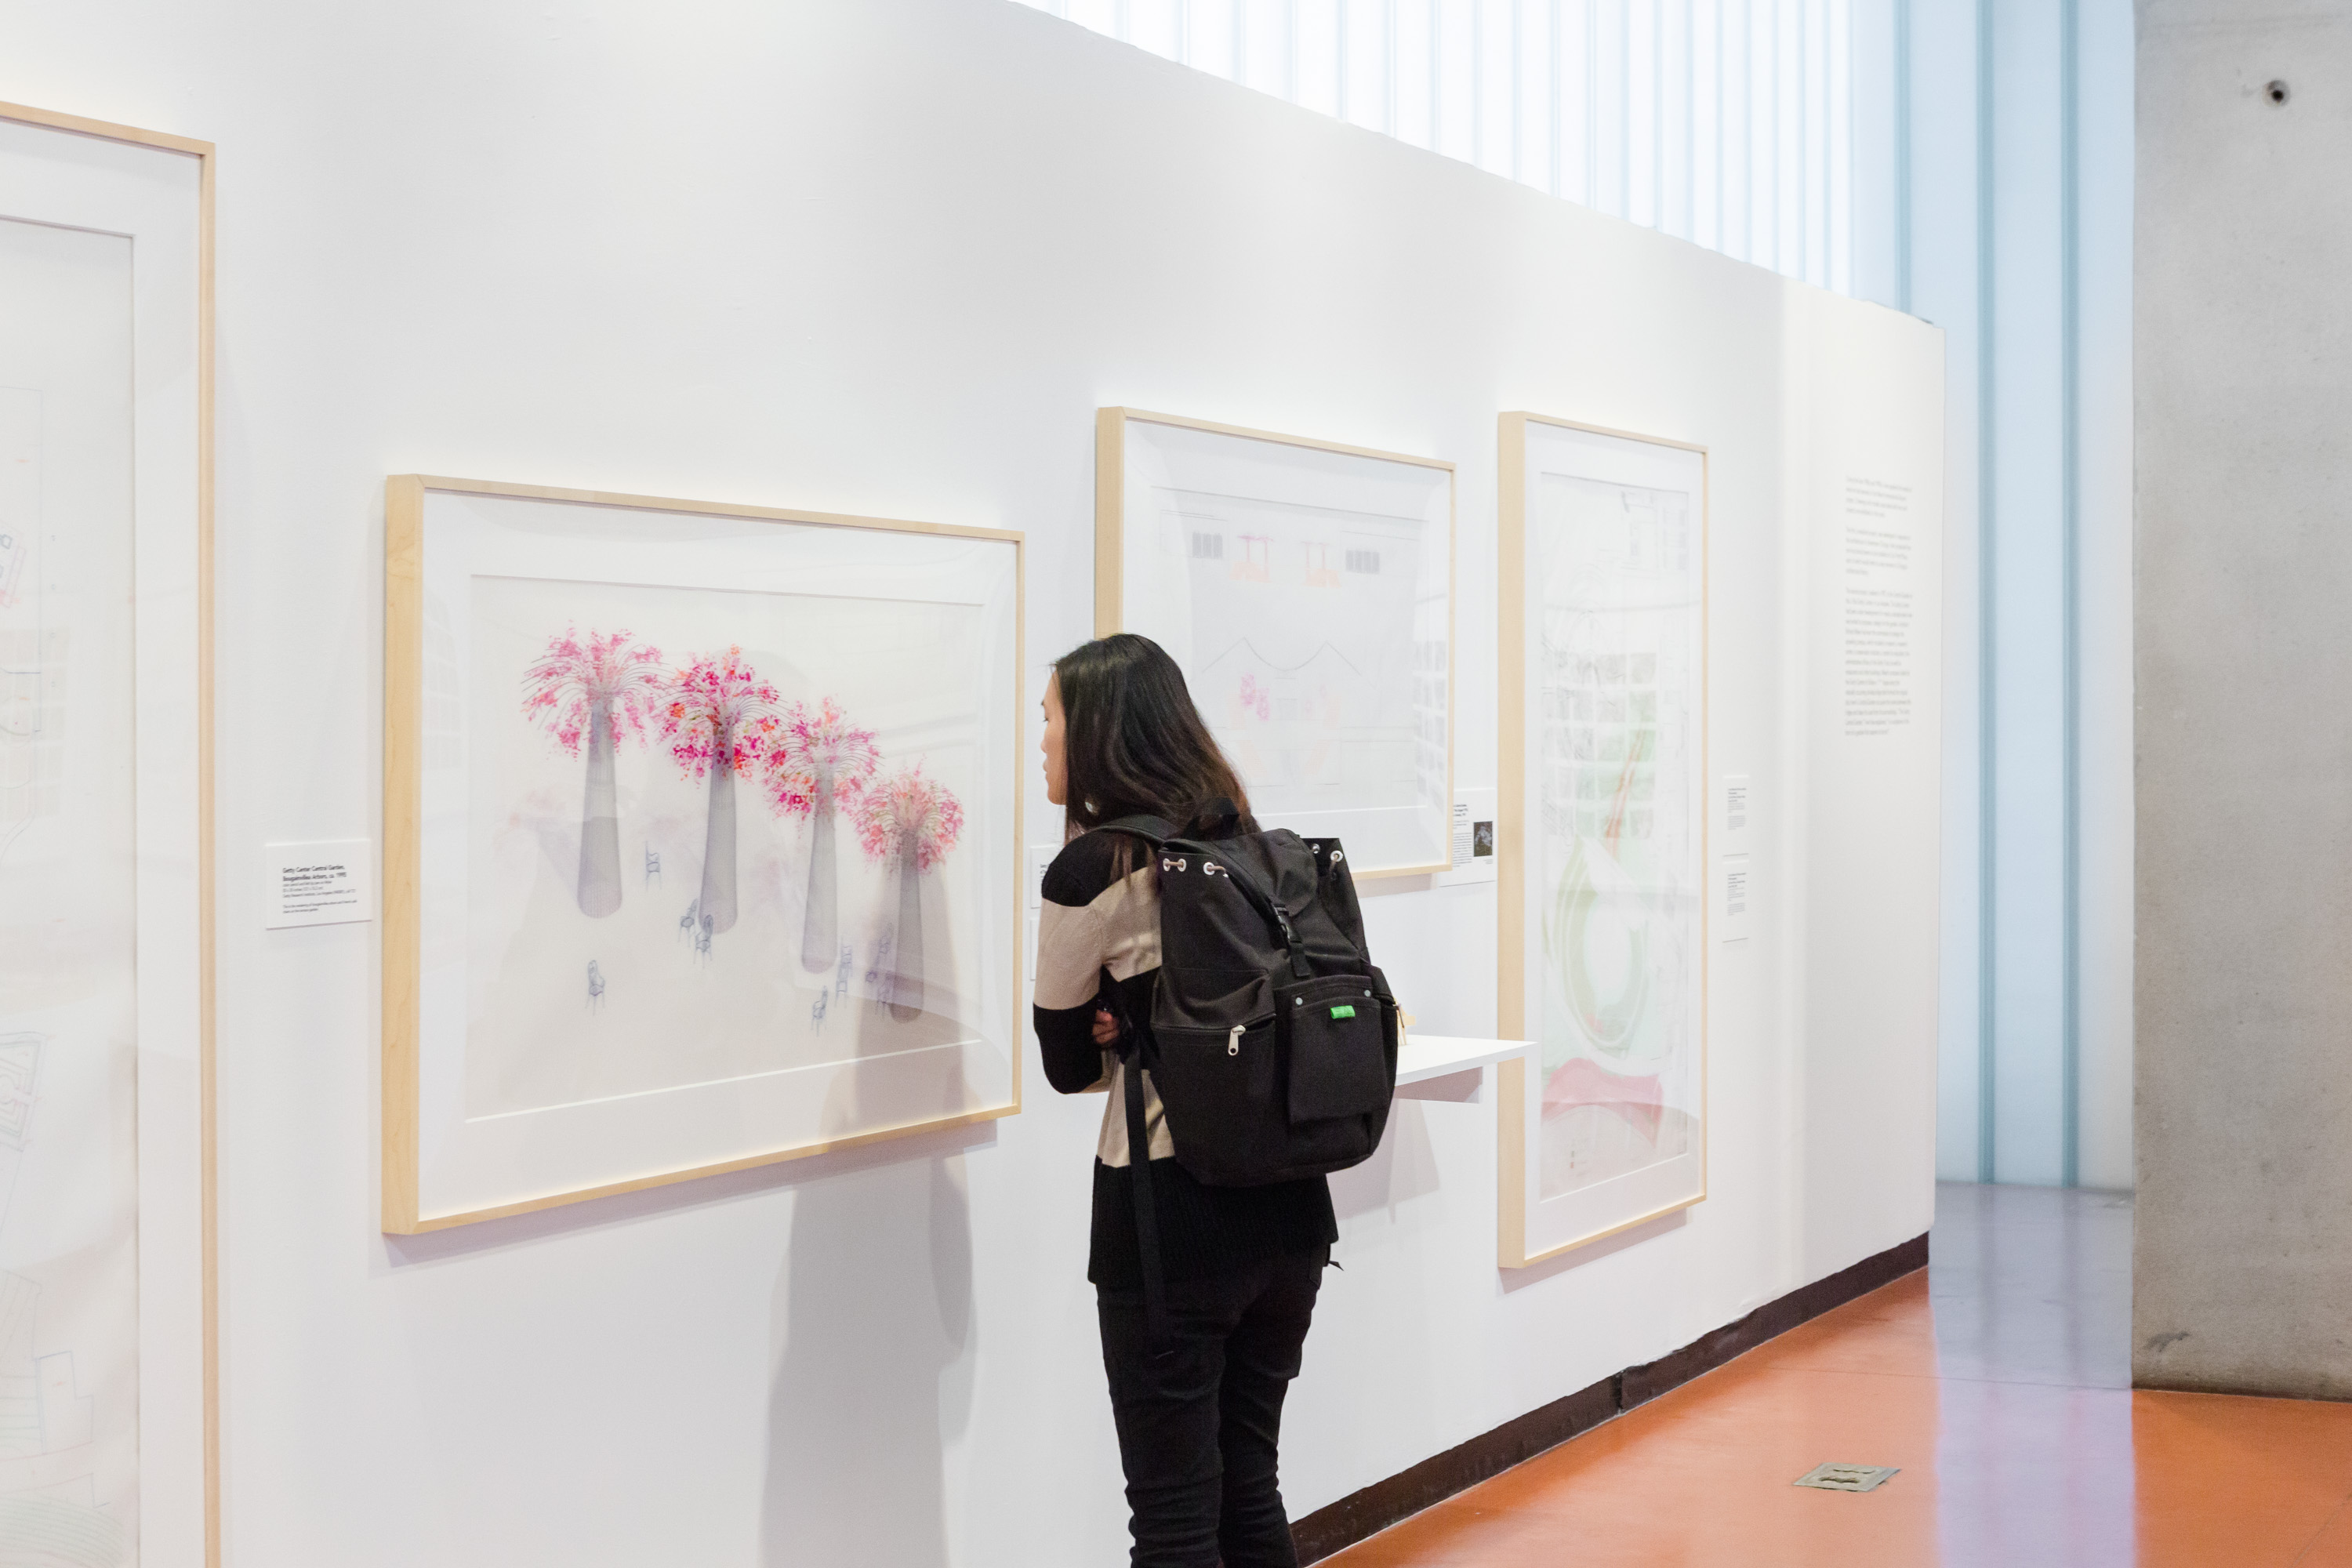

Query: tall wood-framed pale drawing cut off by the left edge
<box><xmin>0</xmin><ymin>106</ymin><xmax>219</xmax><ymax>1568</ymax></box>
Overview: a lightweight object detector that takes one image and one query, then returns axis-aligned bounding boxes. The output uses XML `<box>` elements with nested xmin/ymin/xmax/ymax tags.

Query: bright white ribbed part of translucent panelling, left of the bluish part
<box><xmin>1023</xmin><ymin>0</ymin><xmax>1863</xmax><ymax>294</ymax></box>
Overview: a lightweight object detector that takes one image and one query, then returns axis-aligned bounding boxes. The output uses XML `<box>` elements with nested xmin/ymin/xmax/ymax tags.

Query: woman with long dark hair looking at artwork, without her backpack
<box><xmin>1035</xmin><ymin>635</ymin><xmax>1338</xmax><ymax>1568</ymax></box>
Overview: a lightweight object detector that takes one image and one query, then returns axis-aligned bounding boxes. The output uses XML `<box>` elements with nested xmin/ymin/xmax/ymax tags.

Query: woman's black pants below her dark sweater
<box><xmin>1096</xmin><ymin>1246</ymin><xmax>1331</xmax><ymax>1568</ymax></box>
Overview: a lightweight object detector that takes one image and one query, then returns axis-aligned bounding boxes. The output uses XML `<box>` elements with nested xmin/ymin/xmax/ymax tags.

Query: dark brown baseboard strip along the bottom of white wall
<box><xmin>1291</xmin><ymin>1234</ymin><xmax>1926</xmax><ymax>1563</ymax></box>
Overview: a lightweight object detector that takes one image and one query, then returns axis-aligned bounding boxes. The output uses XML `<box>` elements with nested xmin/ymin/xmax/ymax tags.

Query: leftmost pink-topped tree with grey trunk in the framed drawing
<box><xmin>522</xmin><ymin>628</ymin><xmax>666</xmax><ymax>919</ymax></box>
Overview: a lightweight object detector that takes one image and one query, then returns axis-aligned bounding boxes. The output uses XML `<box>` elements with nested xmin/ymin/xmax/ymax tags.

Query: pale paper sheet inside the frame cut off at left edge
<box><xmin>0</xmin><ymin>219</ymin><xmax>139</xmax><ymax>1563</ymax></box>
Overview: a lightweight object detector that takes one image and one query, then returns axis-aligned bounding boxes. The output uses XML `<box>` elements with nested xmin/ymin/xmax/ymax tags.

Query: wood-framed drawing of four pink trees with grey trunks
<box><xmin>383</xmin><ymin>477</ymin><xmax>1021</xmax><ymax>1232</ymax></box>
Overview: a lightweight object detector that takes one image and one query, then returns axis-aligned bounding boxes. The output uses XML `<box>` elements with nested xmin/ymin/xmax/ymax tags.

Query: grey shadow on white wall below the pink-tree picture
<box><xmin>760</xmin><ymin>1044</ymin><xmax>974</xmax><ymax>1568</ymax></box>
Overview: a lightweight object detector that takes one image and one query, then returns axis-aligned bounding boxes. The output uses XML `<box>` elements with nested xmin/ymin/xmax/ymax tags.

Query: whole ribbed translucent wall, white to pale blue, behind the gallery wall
<box><xmin>1021</xmin><ymin>0</ymin><xmax>2133</xmax><ymax>1187</ymax></box>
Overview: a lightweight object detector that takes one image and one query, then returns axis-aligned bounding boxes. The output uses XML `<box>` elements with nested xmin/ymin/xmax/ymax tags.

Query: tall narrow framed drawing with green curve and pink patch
<box><xmin>1496</xmin><ymin>414</ymin><xmax>1708</xmax><ymax>1267</ymax></box>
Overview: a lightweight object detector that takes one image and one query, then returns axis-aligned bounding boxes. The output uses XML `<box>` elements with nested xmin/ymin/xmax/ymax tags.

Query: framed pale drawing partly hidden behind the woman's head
<box><xmin>1094</xmin><ymin>409</ymin><xmax>1454</xmax><ymax>877</ymax></box>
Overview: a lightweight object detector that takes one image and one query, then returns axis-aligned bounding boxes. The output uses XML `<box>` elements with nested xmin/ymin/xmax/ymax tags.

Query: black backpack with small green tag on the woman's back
<box><xmin>1096</xmin><ymin>815</ymin><xmax>1397</xmax><ymax>1340</ymax></box>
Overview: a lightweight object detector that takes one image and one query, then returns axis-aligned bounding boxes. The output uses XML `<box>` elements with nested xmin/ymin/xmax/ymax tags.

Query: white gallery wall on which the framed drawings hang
<box><xmin>0</xmin><ymin>0</ymin><xmax>1943</xmax><ymax>1568</ymax></box>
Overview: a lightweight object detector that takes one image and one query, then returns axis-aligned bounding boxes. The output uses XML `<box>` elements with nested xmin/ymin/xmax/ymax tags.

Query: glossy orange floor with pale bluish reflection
<box><xmin>1327</xmin><ymin>1187</ymin><xmax>2352</xmax><ymax>1568</ymax></box>
